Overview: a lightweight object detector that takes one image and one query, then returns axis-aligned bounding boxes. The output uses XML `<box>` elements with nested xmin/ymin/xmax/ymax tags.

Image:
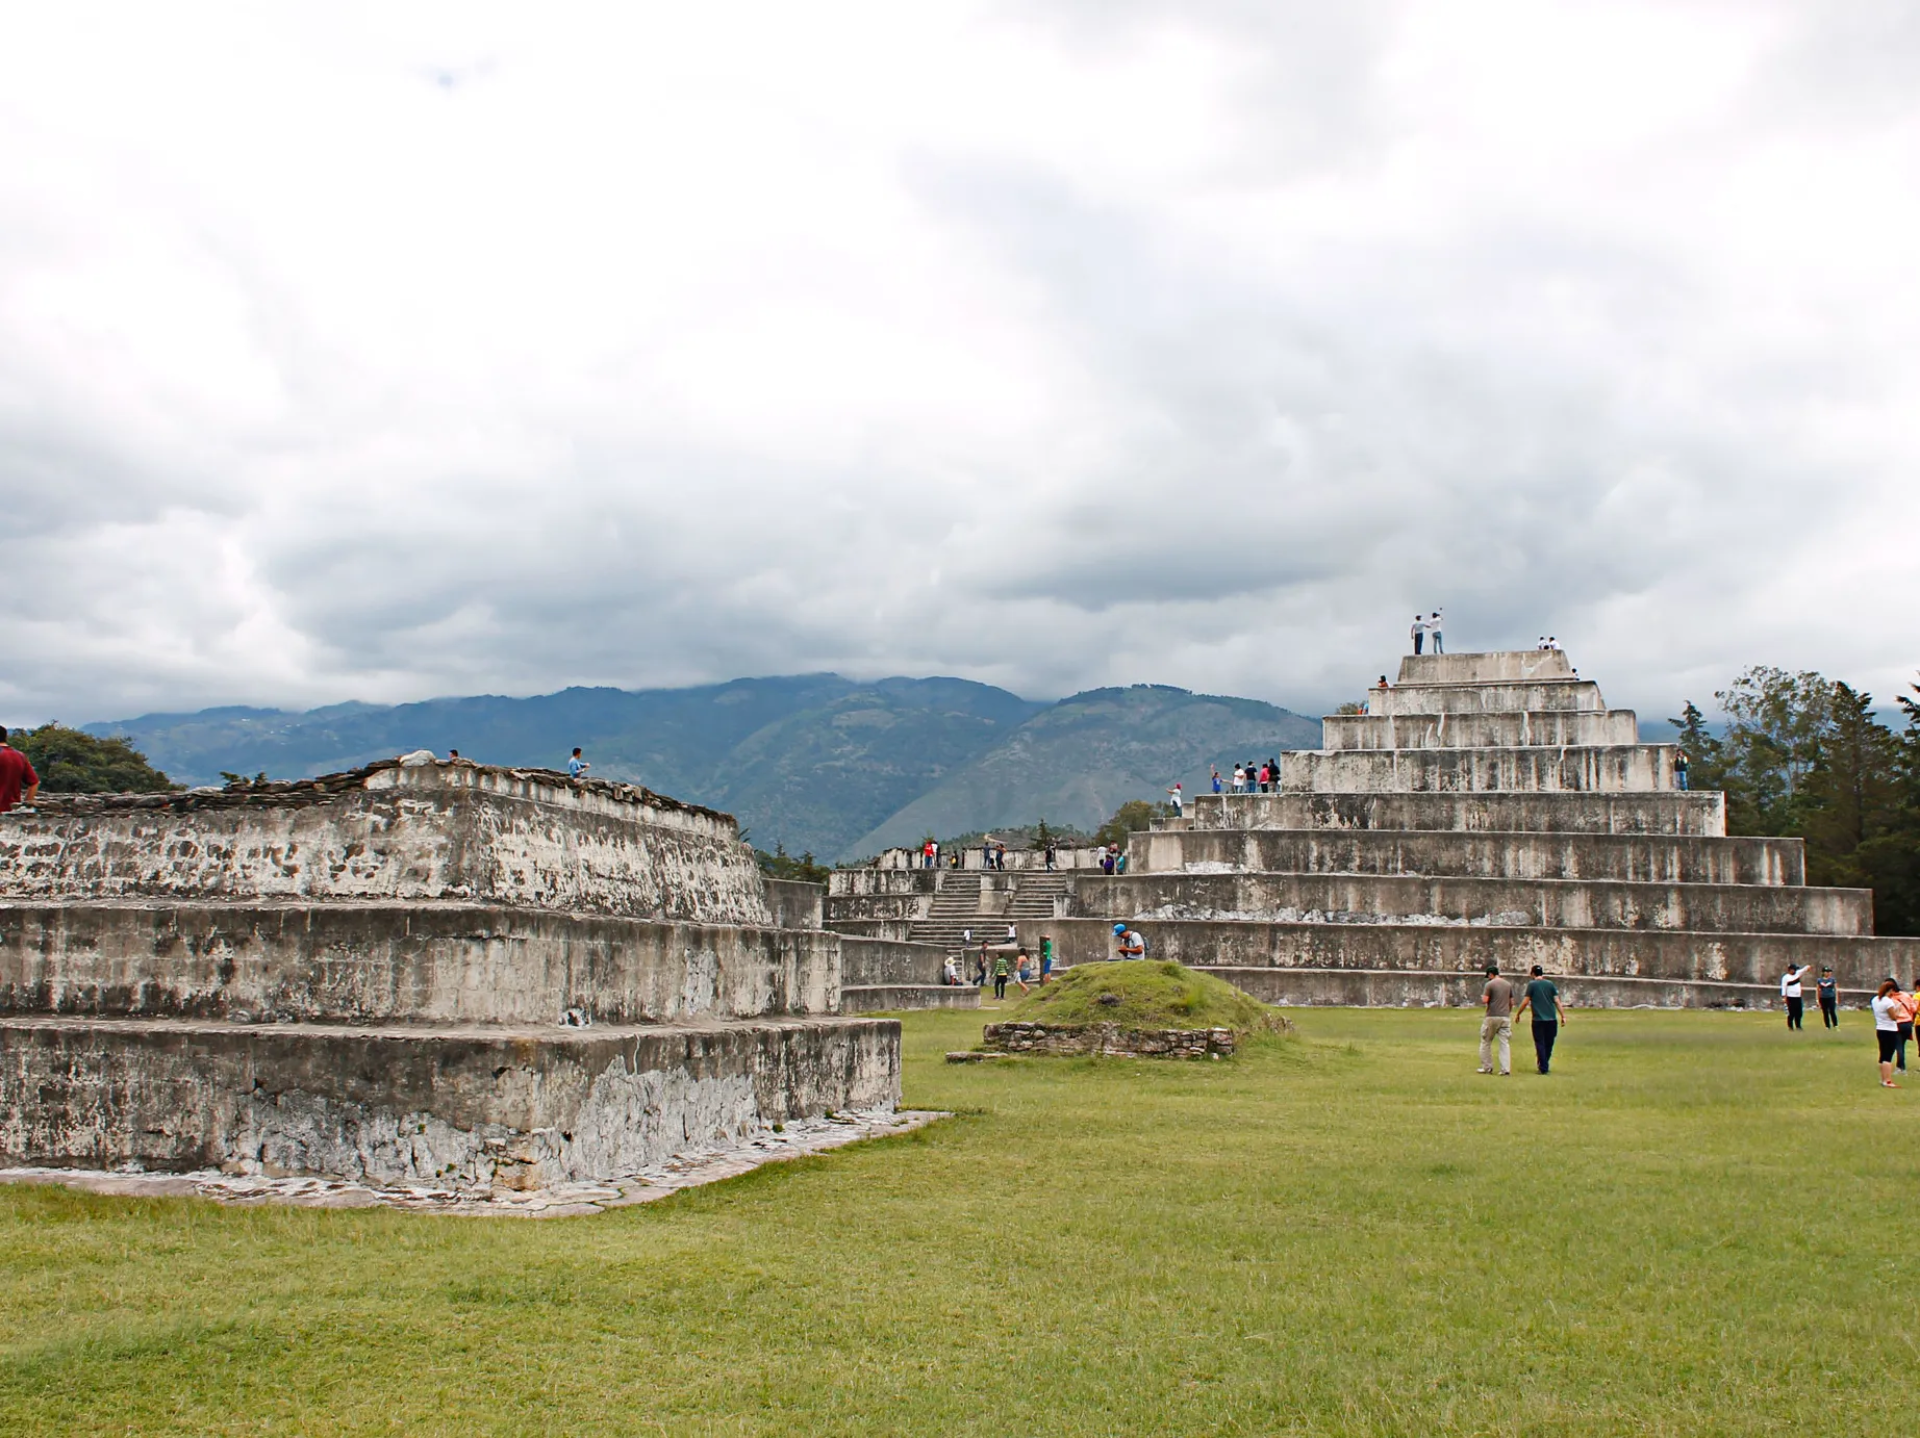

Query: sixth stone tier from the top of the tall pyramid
<box><xmin>1127</xmin><ymin>829</ymin><xmax>1807</xmax><ymax>885</ymax></box>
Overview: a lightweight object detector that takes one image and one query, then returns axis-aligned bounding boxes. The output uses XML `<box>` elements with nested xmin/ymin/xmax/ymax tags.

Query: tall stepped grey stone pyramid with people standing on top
<box><xmin>1021</xmin><ymin>649</ymin><xmax>1920</xmax><ymax>1008</ymax></box>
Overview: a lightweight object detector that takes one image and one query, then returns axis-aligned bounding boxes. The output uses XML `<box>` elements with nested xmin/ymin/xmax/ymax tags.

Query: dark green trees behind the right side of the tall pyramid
<box><xmin>1668</xmin><ymin>666</ymin><xmax>1920</xmax><ymax>933</ymax></box>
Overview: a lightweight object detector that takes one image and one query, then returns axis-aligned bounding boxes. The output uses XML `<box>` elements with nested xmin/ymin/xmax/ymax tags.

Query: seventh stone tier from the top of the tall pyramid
<box><xmin>1071</xmin><ymin>874</ymin><xmax>1874</xmax><ymax>939</ymax></box>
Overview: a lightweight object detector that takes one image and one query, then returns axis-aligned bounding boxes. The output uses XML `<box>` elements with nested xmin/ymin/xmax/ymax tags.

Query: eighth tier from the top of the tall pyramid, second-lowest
<box><xmin>1050</xmin><ymin>918</ymin><xmax>1920</xmax><ymax>991</ymax></box>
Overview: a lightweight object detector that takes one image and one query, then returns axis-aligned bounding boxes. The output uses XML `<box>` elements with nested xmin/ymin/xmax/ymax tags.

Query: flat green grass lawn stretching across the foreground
<box><xmin>0</xmin><ymin>1012</ymin><xmax>1920</xmax><ymax>1434</ymax></box>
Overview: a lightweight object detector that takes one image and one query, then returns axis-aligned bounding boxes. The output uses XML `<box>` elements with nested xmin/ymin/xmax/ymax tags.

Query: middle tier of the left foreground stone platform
<box><xmin>0</xmin><ymin>902</ymin><xmax>849</xmax><ymax>1023</ymax></box>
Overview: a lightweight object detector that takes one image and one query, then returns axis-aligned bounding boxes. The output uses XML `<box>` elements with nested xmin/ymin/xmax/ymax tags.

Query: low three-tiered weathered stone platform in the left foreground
<box><xmin>0</xmin><ymin>762</ymin><xmax>943</xmax><ymax>1190</ymax></box>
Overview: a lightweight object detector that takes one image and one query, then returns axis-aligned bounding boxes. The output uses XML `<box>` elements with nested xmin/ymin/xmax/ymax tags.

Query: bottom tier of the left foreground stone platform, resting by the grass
<box><xmin>0</xmin><ymin>1018</ymin><xmax>900</xmax><ymax>1188</ymax></box>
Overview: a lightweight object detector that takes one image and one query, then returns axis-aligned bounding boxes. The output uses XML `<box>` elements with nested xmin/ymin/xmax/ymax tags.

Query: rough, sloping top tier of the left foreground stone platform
<box><xmin>0</xmin><ymin>762</ymin><xmax>775</xmax><ymax>927</ymax></box>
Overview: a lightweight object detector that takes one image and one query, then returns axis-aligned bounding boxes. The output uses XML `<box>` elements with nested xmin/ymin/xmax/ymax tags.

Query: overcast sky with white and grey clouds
<box><xmin>0</xmin><ymin>0</ymin><xmax>1920</xmax><ymax>722</ymax></box>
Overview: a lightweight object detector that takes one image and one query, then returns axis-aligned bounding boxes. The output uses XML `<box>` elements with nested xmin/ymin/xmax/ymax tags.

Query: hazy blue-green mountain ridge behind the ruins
<box><xmin>84</xmin><ymin>674</ymin><xmax>1319</xmax><ymax>860</ymax></box>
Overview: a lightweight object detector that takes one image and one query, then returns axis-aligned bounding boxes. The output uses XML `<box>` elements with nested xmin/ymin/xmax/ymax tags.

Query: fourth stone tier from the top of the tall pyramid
<box><xmin>1281</xmin><ymin>743</ymin><xmax>1678</xmax><ymax>793</ymax></box>
